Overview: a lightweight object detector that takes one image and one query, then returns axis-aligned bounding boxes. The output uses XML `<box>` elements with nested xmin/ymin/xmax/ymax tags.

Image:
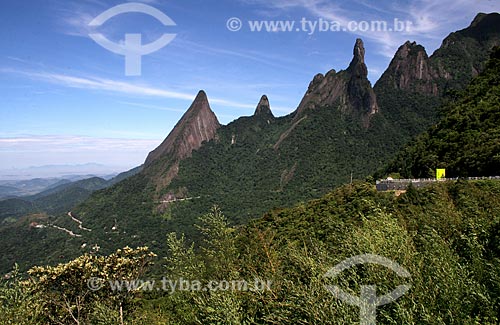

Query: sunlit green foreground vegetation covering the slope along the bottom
<box><xmin>0</xmin><ymin>181</ymin><xmax>500</xmax><ymax>324</ymax></box>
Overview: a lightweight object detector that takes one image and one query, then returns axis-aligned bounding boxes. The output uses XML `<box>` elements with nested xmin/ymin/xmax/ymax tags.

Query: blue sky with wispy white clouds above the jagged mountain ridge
<box><xmin>0</xmin><ymin>0</ymin><xmax>500</xmax><ymax>175</ymax></box>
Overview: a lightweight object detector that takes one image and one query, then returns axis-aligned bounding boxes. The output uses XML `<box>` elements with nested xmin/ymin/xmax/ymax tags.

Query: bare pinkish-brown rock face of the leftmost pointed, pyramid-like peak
<box><xmin>144</xmin><ymin>90</ymin><xmax>220</xmax><ymax>168</ymax></box>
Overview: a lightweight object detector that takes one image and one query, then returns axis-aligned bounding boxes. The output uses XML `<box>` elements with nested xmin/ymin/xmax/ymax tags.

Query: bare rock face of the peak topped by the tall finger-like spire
<box><xmin>295</xmin><ymin>39</ymin><xmax>379</xmax><ymax>125</ymax></box>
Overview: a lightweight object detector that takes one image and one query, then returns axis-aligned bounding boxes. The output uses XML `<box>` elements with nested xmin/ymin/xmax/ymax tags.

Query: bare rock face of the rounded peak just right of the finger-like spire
<box><xmin>380</xmin><ymin>41</ymin><xmax>439</xmax><ymax>96</ymax></box>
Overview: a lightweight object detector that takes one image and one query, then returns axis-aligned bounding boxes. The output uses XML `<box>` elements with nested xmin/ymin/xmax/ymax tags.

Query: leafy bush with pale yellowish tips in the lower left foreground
<box><xmin>24</xmin><ymin>247</ymin><xmax>155</xmax><ymax>324</ymax></box>
